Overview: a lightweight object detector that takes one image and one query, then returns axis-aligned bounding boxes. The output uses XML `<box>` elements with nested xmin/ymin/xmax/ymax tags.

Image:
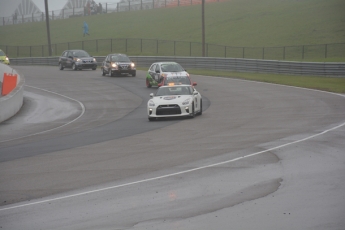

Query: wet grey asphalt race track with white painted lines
<box><xmin>0</xmin><ymin>66</ymin><xmax>345</xmax><ymax>229</ymax></box>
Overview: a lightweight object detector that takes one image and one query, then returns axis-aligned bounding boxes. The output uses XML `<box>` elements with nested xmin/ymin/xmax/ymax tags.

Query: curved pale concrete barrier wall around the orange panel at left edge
<box><xmin>0</xmin><ymin>63</ymin><xmax>25</xmax><ymax>122</ymax></box>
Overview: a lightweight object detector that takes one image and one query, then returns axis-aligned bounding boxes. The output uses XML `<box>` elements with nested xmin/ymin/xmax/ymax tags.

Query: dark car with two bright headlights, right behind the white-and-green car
<box><xmin>101</xmin><ymin>54</ymin><xmax>137</xmax><ymax>77</ymax></box>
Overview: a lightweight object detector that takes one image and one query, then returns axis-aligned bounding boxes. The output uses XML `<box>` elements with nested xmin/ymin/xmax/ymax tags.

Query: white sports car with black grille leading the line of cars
<box><xmin>147</xmin><ymin>85</ymin><xmax>202</xmax><ymax>121</ymax></box>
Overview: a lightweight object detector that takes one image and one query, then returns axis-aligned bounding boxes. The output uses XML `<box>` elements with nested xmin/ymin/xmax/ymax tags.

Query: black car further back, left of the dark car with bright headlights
<box><xmin>59</xmin><ymin>50</ymin><xmax>97</xmax><ymax>70</ymax></box>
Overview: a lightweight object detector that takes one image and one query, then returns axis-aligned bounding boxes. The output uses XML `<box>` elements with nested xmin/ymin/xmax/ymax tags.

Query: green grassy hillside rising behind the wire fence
<box><xmin>0</xmin><ymin>0</ymin><xmax>345</xmax><ymax>47</ymax></box>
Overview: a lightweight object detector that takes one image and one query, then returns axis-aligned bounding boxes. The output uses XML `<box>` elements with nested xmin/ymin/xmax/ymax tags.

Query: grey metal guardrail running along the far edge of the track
<box><xmin>10</xmin><ymin>56</ymin><xmax>345</xmax><ymax>77</ymax></box>
